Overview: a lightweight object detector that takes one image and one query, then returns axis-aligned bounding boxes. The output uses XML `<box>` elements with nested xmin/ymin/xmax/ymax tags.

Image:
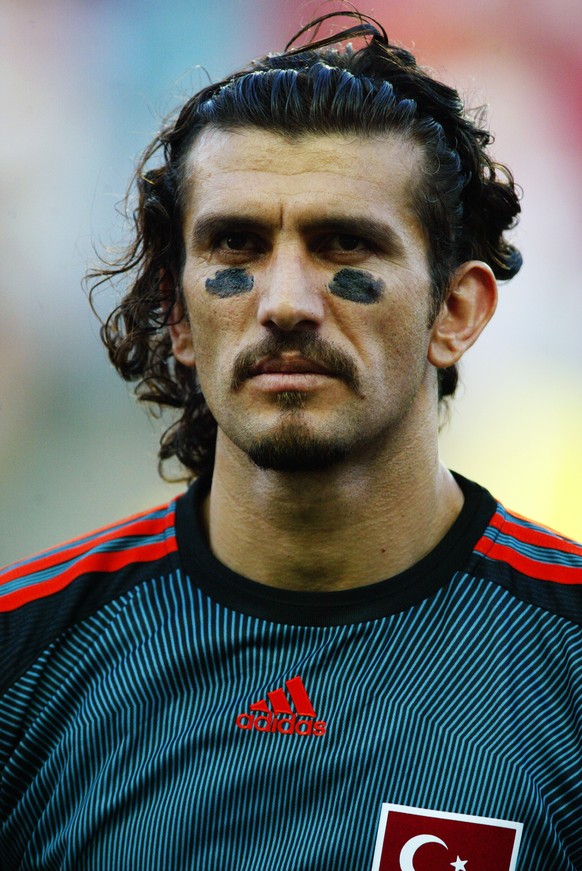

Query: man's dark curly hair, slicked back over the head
<box><xmin>88</xmin><ymin>12</ymin><xmax>522</xmax><ymax>480</ymax></box>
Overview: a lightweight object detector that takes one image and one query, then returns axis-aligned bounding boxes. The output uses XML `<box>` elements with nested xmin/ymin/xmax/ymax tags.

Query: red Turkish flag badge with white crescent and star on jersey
<box><xmin>372</xmin><ymin>804</ymin><xmax>523</xmax><ymax>871</ymax></box>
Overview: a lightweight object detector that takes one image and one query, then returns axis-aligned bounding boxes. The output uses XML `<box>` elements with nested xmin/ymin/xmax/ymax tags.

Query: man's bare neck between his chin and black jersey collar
<box><xmin>203</xmin><ymin>416</ymin><xmax>463</xmax><ymax>591</ymax></box>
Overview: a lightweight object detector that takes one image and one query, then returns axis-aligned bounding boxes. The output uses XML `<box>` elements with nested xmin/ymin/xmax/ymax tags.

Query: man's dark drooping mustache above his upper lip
<box><xmin>231</xmin><ymin>332</ymin><xmax>362</xmax><ymax>396</ymax></box>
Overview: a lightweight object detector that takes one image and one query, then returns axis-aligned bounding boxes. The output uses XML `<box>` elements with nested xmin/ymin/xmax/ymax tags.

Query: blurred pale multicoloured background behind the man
<box><xmin>0</xmin><ymin>0</ymin><xmax>582</xmax><ymax>564</ymax></box>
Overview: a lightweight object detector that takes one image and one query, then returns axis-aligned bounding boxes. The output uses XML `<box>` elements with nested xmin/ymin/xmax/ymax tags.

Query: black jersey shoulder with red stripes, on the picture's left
<box><xmin>0</xmin><ymin>500</ymin><xmax>177</xmax><ymax>692</ymax></box>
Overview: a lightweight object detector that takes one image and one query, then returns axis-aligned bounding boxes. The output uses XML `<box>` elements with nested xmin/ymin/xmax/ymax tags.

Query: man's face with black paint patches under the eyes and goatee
<box><xmin>172</xmin><ymin>128</ymin><xmax>436</xmax><ymax>470</ymax></box>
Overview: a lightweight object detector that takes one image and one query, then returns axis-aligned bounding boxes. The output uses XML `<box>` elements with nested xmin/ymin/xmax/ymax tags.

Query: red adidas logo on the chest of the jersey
<box><xmin>236</xmin><ymin>676</ymin><xmax>327</xmax><ymax>737</ymax></box>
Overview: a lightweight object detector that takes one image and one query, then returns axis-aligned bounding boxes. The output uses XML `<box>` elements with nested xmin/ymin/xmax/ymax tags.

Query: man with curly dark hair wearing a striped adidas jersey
<box><xmin>0</xmin><ymin>14</ymin><xmax>582</xmax><ymax>871</ymax></box>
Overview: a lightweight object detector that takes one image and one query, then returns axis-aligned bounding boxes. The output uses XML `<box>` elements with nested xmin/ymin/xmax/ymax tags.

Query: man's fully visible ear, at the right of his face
<box><xmin>428</xmin><ymin>260</ymin><xmax>497</xmax><ymax>369</ymax></box>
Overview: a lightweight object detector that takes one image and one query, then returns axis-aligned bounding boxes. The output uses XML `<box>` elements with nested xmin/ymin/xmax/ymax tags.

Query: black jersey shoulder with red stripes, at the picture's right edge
<box><xmin>474</xmin><ymin>503</ymin><xmax>582</xmax><ymax>624</ymax></box>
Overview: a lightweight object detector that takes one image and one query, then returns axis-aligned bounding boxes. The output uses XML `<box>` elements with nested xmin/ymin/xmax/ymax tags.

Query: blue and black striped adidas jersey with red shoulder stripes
<box><xmin>0</xmin><ymin>476</ymin><xmax>582</xmax><ymax>871</ymax></box>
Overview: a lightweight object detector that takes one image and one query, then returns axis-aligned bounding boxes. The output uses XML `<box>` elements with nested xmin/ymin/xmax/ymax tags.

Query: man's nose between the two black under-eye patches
<box><xmin>257</xmin><ymin>246</ymin><xmax>325</xmax><ymax>331</ymax></box>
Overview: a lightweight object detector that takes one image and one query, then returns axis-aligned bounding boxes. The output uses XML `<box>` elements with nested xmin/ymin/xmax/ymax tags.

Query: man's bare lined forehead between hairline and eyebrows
<box><xmin>185</xmin><ymin>128</ymin><xmax>422</xmax><ymax>233</ymax></box>
